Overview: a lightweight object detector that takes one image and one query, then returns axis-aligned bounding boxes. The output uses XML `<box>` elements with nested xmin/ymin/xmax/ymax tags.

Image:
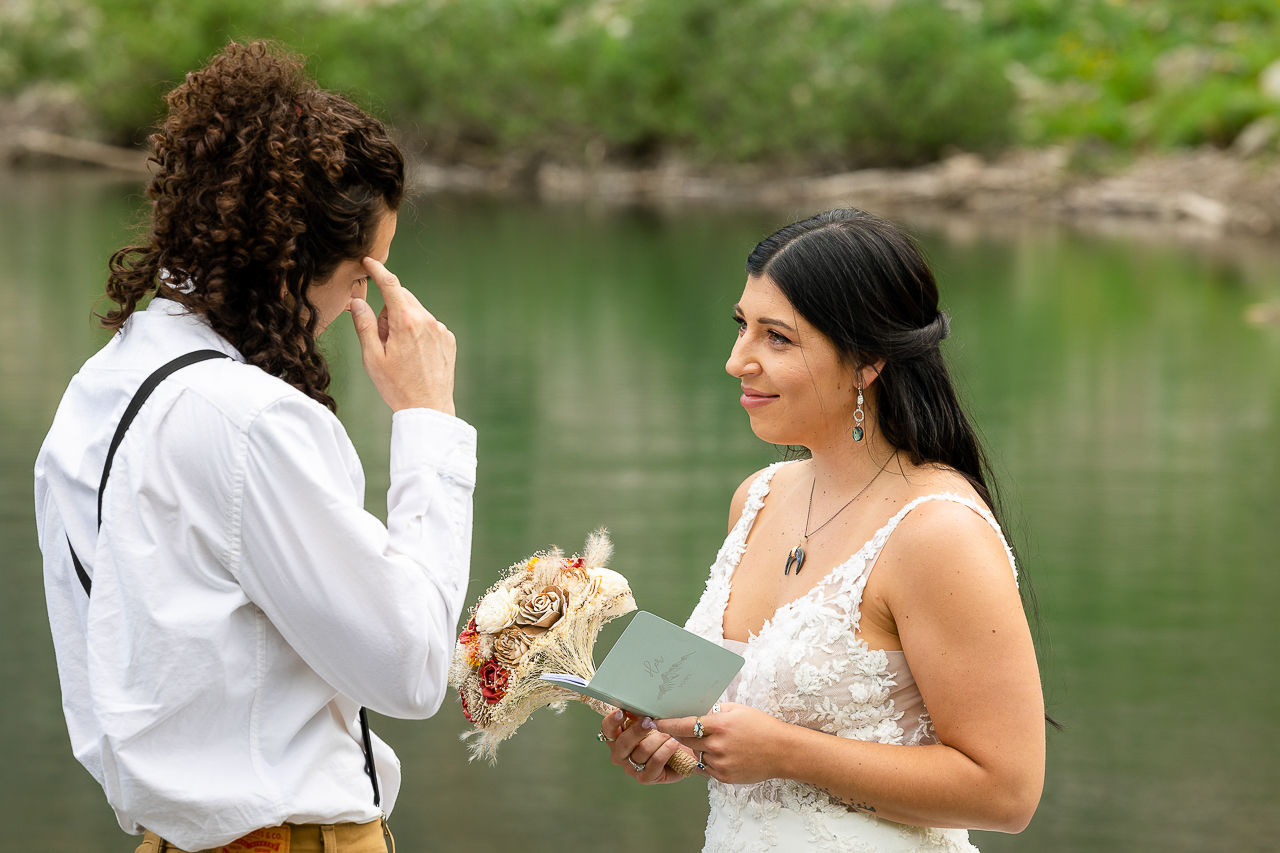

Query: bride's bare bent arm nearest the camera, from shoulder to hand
<box><xmin>655</xmin><ymin>501</ymin><xmax>1044</xmax><ymax>833</ymax></box>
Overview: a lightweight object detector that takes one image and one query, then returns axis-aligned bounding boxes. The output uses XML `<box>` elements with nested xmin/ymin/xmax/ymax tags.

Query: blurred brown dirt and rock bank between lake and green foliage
<box><xmin>0</xmin><ymin>126</ymin><xmax>1280</xmax><ymax>238</ymax></box>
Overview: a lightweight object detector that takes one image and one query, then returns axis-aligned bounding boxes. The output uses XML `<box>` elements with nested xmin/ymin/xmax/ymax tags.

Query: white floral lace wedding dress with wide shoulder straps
<box><xmin>685</xmin><ymin>462</ymin><xmax>1016</xmax><ymax>853</ymax></box>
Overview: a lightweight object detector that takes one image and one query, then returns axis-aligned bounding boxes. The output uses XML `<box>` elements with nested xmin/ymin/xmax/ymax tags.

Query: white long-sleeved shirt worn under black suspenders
<box><xmin>36</xmin><ymin>300</ymin><xmax>476</xmax><ymax>850</ymax></box>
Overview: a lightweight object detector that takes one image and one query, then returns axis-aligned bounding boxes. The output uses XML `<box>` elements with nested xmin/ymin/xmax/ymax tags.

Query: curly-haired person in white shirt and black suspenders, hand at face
<box><xmin>36</xmin><ymin>42</ymin><xmax>476</xmax><ymax>853</ymax></box>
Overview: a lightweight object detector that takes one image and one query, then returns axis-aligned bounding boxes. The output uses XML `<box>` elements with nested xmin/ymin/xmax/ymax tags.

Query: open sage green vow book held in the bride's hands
<box><xmin>540</xmin><ymin>610</ymin><xmax>742</xmax><ymax>720</ymax></box>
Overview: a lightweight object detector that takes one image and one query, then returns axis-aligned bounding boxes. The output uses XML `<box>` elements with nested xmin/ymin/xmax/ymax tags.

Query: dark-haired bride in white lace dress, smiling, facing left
<box><xmin>600</xmin><ymin>210</ymin><xmax>1044</xmax><ymax>853</ymax></box>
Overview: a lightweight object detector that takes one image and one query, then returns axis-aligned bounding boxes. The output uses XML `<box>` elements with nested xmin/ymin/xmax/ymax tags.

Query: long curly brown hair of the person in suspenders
<box><xmin>100</xmin><ymin>41</ymin><xmax>404</xmax><ymax>410</ymax></box>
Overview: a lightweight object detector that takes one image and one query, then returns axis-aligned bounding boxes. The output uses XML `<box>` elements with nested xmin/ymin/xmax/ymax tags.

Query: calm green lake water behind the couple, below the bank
<box><xmin>0</xmin><ymin>173</ymin><xmax>1280</xmax><ymax>853</ymax></box>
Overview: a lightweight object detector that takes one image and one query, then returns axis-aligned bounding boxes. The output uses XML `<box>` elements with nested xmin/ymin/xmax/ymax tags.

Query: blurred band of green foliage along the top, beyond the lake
<box><xmin>0</xmin><ymin>0</ymin><xmax>1280</xmax><ymax>162</ymax></box>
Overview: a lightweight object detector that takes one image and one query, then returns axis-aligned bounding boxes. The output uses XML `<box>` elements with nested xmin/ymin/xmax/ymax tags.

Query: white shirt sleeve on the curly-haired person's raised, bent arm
<box><xmin>227</xmin><ymin>397</ymin><xmax>476</xmax><ymax>719</ymax></box>
